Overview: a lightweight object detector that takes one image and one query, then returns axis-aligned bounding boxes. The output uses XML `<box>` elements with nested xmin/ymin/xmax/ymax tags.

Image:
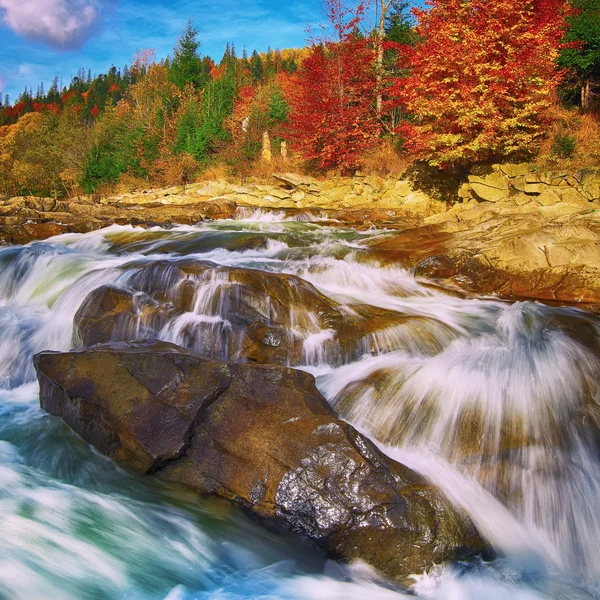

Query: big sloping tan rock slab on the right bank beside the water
<box><xmin>370</xmin><ymin>203</ymin><xmax>600</xmax><ymax>311</ymax></box>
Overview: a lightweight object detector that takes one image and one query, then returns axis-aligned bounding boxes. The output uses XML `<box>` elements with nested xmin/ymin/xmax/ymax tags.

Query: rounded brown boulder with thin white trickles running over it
<box><xmin>73</xmin><ymin>259</ymin><xmax>418</xmax><ymax>366</ymax></box>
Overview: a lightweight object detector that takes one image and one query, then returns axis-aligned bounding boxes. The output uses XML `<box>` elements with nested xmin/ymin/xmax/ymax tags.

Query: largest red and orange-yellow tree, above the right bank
<box><xmin>388</xmin><ymin>0</ymin><xmax>567</xmax><ymax>166</ymax></box>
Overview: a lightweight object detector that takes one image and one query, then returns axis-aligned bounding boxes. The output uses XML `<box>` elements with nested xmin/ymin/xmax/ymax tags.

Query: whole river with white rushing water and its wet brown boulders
<box><xmin>0</xmin><ymin>210</ymin><xmax>600</xmax><ymax>600</ymax></box>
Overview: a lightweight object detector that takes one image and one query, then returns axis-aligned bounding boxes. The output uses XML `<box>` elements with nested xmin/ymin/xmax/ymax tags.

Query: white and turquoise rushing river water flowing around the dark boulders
<box><xmin>0</xmin><ymin>213</ymin><xmax>600</xmax><ymax>600</ymax></box>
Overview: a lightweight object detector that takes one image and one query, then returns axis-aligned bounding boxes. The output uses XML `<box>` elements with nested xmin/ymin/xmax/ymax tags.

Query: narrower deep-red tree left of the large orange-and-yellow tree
<box><xmin>288</xmin><ymin>0</ymin><xmax>380</xmax><ymax>169</ymax></box>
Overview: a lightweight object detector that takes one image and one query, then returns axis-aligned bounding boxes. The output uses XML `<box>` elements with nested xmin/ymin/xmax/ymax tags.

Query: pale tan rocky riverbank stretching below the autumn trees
<box><xmin>0</xmin><ymin>165</ymin><xmax>600</xmax><ymax>312</ymax></box>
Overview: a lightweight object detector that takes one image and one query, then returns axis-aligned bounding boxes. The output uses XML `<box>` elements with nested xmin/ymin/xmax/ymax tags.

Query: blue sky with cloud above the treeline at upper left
<box><xmin>0</xmin><ymin>0</ymin><xmax>323</xmax><ymax>101</ymax></box>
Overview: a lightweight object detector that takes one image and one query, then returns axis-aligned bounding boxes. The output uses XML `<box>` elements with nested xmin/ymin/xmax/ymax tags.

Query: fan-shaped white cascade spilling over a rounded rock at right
<box><xmin>321</xmin><ymin>303</ymin><xmax>600</xmax><ymax>576</ymax></box>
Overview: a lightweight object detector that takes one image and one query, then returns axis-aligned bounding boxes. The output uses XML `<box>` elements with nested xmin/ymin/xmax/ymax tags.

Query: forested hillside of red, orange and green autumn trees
<box><xmin>0</xmin><ymin>0</ymin><xmax>600</xmax><ymax>196</ymax></box>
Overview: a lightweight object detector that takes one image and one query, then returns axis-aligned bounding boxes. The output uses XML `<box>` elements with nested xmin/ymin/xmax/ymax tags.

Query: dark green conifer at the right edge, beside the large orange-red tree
<box><xmin>558</xmin><ymin>0</ymin><xmax>600</xmax><ymax>110</ymax></box>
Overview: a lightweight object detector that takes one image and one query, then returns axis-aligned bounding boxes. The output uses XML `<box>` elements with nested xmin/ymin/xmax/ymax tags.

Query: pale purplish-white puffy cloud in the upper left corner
<box><xmin>0</xmin><ymin>0</ymin><xmax>107</xmax><ymax>48</ymax></box>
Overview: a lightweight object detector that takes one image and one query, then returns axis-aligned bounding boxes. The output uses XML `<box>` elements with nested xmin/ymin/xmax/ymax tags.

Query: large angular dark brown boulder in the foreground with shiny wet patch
<box><xmin>34</xmin><ymin>342</ymin><xmax>486</xmax><ymax>583</ymax></box>
